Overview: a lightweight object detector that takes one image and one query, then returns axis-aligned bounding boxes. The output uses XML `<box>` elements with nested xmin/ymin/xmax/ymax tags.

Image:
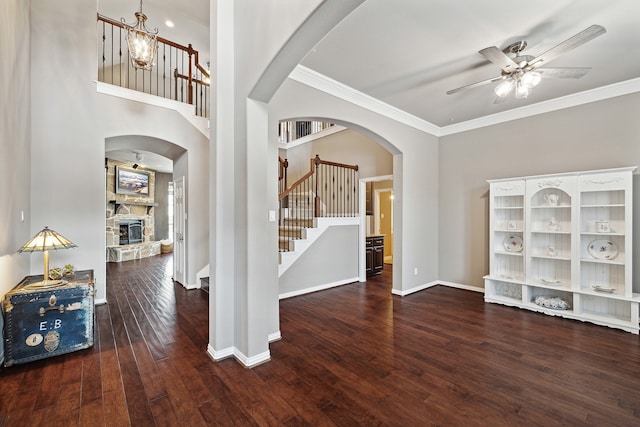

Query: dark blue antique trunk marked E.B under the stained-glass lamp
<box><xmin>2</xmin><ymin>270</ymin><xmax>94</xmax><ymax>366</ymax></box>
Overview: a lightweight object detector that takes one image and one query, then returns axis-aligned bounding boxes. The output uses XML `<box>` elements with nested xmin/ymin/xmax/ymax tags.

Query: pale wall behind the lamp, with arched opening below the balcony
<box><xmin>31</xmin><ymin>0</ymin><xmax>208</xmax><ymax>301</ymax></box>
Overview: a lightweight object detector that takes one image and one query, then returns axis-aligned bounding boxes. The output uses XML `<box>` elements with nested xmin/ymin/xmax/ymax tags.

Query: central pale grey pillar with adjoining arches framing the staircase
<box><xmin>208</xmin><ymin>0</ymin><xmax>438</xmax><ymax>366</ymax></box>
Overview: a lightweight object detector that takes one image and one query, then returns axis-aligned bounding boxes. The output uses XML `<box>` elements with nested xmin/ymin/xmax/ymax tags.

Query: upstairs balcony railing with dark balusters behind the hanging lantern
<box><xmin>98</xmin><ymin>14</ymin><xmax>211</xmax><ymax>117</ymax></box>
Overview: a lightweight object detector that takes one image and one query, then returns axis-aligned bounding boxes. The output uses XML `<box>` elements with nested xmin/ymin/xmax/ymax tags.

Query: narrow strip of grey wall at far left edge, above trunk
<box><xmin>0</xmin><ymin>0</ymin><xmax>35</xmax><ymax>363</ymax></box>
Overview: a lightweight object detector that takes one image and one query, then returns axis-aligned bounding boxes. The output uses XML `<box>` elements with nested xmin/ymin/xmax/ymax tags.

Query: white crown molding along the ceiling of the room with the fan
<box><xmin>289</xmin><ymin>65</ymin><xmax>640</xmax><ymax>137</ymax></box>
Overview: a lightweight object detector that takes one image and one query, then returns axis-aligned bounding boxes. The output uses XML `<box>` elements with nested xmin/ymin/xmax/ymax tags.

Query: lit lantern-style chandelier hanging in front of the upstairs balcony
<box><xmin>121</xmin><ymin>0</ymin><xmax>158</xmax><ymax>70</ymax></box>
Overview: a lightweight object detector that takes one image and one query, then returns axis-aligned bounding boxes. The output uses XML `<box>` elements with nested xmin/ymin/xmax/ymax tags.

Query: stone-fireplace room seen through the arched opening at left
<box><xmin>105</xmin><ymin>135</ymin><xmax>188</xmax><ymax>280</ymax></box>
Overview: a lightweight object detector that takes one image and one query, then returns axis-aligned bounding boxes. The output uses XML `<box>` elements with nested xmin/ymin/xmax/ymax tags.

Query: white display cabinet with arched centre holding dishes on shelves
<box><xmin>485</xmin><ymin>167</ymin><xmax>640</xmax><ymax>334</ymax></box>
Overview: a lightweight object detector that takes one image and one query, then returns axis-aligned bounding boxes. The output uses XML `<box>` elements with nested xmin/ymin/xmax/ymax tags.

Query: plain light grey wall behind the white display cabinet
<box><xmin>438</xmin><ymin>94</ymin><xmax>640</xmax><ymax>288</ymax></box>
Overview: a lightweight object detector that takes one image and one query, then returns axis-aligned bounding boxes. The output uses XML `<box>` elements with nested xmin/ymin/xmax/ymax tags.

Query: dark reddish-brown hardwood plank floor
<box><xmin>0</xmin><ymin>254</ymin><xmax>640</xmax><ymax>427</ymax></box>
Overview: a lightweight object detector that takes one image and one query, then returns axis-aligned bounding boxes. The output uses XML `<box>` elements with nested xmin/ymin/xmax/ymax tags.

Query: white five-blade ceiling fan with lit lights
<box><xmin>447</xmin><ymin>25</ymin><xmax>606</xmax><ymax>103</ymax></box>
